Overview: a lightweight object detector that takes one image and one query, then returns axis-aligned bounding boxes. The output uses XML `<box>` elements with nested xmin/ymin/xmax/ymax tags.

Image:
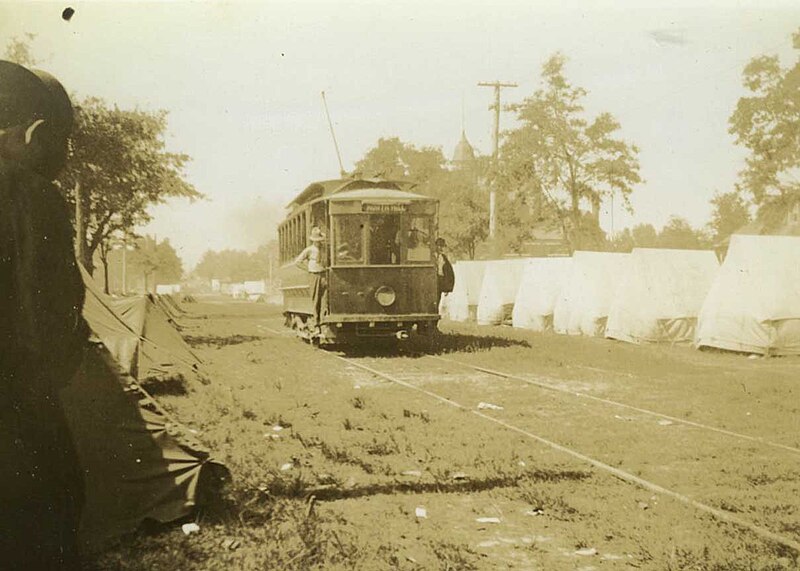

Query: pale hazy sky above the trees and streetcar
<box><xmin>0</xmin><ymin>0</ymin><xmax>800</xmax><ymax>266</ymax></box>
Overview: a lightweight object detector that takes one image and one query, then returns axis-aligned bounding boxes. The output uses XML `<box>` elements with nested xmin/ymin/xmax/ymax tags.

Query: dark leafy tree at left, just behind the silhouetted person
<box><xmin>58</xmin><ymin>98</ymin><xmax>202</xmax><ymax>272</ymax></box>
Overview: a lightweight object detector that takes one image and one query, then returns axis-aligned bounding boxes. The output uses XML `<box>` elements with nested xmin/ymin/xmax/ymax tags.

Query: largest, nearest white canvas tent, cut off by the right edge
<box><xmin>696</xmin><ymin>234</ymin><xmax>800</xmax><ymax>355</ymax></box>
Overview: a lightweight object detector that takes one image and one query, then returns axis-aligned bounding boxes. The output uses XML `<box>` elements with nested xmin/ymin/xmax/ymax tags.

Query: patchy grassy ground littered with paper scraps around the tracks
<box><xmin>88</xmin><ymin>303</ymin><xmax>800</xmax><ymax>571</ymax></box>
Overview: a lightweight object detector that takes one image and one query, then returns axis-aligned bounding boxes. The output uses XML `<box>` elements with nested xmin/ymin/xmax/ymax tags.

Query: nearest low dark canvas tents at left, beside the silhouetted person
<box><xmin>61</xmin><ymin>272</ymin><xmax>227</xmax><ymax>549</ymax></box>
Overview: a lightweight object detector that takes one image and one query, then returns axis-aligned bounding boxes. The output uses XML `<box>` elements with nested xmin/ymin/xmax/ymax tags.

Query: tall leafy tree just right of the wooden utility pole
<box><xmin>498</xmin><ymin>54</ymin><xmax>642</xmax><ymax>248</ymax></box>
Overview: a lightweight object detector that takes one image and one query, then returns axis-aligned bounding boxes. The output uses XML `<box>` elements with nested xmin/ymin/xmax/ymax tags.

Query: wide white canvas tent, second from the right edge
<box><xmin>606</xmin><ymin>248</ymin><xmax>719</xmax><ymax>343</ymax></box>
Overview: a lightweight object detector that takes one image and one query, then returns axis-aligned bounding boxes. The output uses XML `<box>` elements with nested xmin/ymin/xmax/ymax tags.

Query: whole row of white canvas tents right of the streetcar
<box><xmin>442</xmin><ymin>235</ymin><xmax>800</xmax><ymax>355</ymax></box>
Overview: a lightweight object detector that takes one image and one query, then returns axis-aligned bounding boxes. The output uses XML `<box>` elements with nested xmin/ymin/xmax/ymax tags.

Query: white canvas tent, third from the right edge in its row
<box><xmin>553</xmin><ymin>252</ymin><xmax>628</xmax><ymax>336</ymax></box>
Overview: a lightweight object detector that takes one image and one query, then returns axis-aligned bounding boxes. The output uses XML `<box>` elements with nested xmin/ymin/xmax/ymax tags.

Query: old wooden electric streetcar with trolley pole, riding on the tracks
<box><xmin>278</xmin><ymin>178</ymin><xmax>439</xmax><ymax>344</ymax></box>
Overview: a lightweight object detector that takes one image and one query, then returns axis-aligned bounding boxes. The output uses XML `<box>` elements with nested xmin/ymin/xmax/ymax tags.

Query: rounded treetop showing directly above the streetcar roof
<box><xmin>356</xmin><ymin>137</ymin><xmax>447</xmax><ymax>184</ymax></box>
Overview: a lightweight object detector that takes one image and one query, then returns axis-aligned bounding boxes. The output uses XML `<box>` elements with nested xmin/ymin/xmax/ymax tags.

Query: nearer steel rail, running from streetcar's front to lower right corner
<box><xmin>328</xmin><ymin>353</ymin><xmax>800</xmax><ymax>553</ymax></box>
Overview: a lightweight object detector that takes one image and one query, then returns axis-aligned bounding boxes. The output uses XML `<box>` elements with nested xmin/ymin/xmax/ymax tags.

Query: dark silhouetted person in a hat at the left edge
<box><xmin>0</xmin><ymin>61</ymin><xmax>88</xmax><ymax>571</ymax></box>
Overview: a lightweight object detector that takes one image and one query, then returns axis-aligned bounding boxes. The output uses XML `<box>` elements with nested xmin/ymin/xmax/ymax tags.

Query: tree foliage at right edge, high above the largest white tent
<box><xmin>729</xmin><ymin>29</ymin><xmax>800</xmax><ymax>210</ymax></box>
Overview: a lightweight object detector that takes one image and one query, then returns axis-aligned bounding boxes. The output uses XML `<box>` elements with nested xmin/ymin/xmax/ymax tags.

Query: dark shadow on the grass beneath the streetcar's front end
<box><xmin>330</xmin><ymin>332</ymin><xmax>531</xmax><ymax>357</ymax></box>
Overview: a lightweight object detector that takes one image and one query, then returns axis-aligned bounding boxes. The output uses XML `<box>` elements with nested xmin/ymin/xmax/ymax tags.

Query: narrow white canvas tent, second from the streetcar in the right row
<box><xmin>477</xmin><ymin>258</ymin><xmax>528</xmax><ymax>325</ymax></box>
